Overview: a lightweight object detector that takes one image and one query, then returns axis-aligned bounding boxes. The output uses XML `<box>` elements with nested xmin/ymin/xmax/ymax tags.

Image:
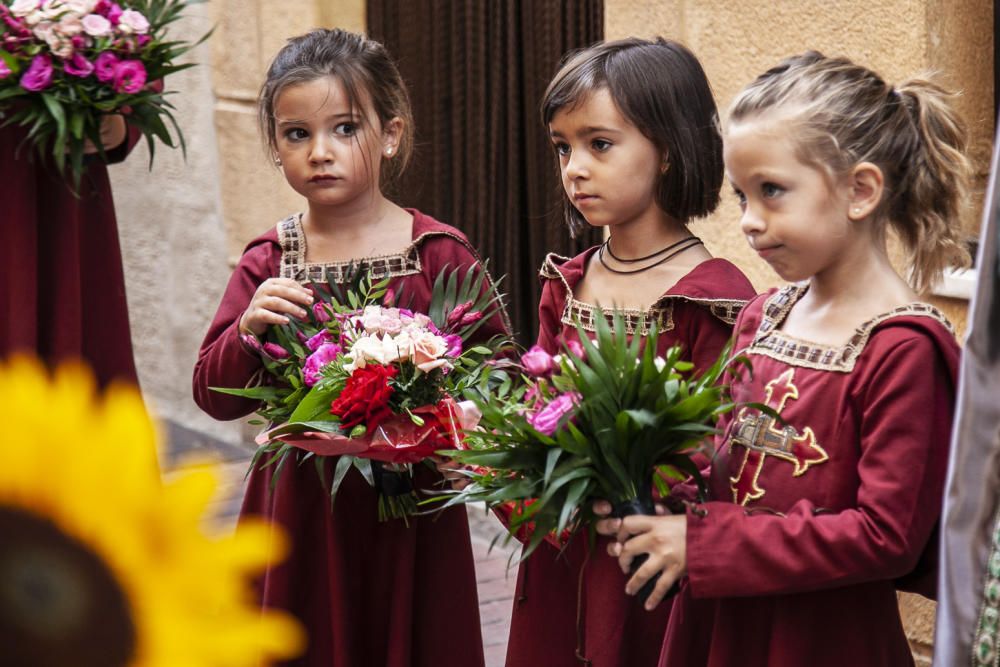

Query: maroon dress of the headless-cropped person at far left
<box><xmin>0</xmin><ymin>127</ymin><xmax>139</xmax><ymax>385</ymax></box>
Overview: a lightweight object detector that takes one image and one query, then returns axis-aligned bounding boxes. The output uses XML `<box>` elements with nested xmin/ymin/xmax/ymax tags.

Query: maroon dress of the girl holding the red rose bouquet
<box><xmin>194</xmin><ymin>211</ymin><xmax>504</xmax><ymax>667</ymax></box>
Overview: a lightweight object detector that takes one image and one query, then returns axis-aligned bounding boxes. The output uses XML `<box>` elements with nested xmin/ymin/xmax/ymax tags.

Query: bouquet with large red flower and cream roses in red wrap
<box><xmin>214</xmin><ymin>269</ymin><xmax>507</xmax><ymax>520</ymax></box>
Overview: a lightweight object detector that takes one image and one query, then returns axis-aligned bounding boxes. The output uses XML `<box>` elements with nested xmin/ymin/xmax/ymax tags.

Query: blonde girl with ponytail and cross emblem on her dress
<box><xmin>596</xmin><ymin>52</ymin><xmax>970</xmax><ymax>667</ymax></box>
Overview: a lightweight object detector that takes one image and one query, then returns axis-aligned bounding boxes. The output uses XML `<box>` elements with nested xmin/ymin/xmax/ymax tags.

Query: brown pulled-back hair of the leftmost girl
<box><xmin>257</xmin><ymin>29</ymin><xmax>413</xmax><ymax>190</ymax></box>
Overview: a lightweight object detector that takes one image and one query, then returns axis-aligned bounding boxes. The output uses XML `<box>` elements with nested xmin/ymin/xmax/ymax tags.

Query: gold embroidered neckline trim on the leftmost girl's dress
<box><xmin>278</xmin><ymin>213</ymin><xmax>424</xmax><ymax>283</ymax></box>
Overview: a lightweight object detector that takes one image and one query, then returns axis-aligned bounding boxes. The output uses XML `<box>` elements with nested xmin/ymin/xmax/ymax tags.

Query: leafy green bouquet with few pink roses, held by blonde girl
<box><xmin>444</xmin><ymin>314</ymin><xmax>752</xmax><ymax>598</ymax></box>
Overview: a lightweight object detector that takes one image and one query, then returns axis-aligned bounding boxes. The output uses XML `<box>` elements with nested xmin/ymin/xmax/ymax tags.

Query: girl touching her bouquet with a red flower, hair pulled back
<box><xmin>194</xmin><ymin>30</ymin><xmax>507</xmax><ymax>667</ymax></box>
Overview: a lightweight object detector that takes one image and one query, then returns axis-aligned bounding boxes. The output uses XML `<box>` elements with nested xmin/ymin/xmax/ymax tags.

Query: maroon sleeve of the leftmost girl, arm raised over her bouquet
<box><xmin>193</xmin><ymin>244</ymin><xmax>280</xmax><ymax>419</ymax></box>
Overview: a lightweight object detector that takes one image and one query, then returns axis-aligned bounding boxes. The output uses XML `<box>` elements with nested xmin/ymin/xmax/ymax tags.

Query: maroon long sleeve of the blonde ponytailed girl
<box><xmin>687</xmin><ymin>328</ymin><xmax>954</xmax><ymax>598</ymax></box>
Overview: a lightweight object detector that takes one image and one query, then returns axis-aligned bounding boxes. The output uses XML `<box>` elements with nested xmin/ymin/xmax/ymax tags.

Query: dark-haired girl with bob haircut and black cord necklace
<box><xmin>507</xmin><ymin>38</ymin><xmax>754</xmax><ymax>667</ymax></box>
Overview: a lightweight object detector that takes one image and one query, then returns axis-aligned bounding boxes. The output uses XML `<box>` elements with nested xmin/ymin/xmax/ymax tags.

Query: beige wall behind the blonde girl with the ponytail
<box><xmin>605</xmin><ymin>0</ymin><xmax>994</xmax><ymax>664</ymax></box>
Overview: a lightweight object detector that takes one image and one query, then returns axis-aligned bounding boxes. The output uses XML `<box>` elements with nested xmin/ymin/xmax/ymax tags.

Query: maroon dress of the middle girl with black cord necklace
<box><xmin>507</xmin><ymin>248</ymin><xmax>754</xmax><ymax>667</ymax></box>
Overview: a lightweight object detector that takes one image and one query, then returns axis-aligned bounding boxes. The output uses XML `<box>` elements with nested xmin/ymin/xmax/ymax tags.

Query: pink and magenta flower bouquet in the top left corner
<box><xmin>0</xmin><ymin>0</ymin><xmax>208</xmax><ymax>190</ymax></box>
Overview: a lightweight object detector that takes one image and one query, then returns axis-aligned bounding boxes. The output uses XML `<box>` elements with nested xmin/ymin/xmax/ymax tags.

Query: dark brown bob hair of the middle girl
<box><xmin>541</xmin><ymin>37</ymin><xmax>724</xmax><ymax>233</ymax></box>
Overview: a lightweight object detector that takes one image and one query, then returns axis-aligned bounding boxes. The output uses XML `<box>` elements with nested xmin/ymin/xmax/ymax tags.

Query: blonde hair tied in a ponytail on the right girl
<box><xmin>728</xmin><ymin>51</ymin><xmax>972</xmax><ymax>292</ymax></box>
